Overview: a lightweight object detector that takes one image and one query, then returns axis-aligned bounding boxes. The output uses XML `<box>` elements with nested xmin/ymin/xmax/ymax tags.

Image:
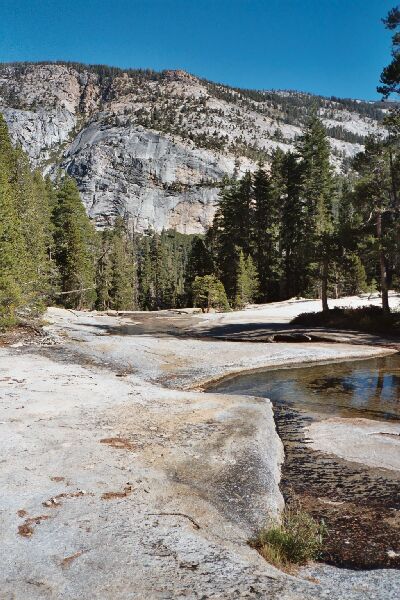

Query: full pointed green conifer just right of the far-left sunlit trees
<box><xmin>54</xmin><ymin>177</ymin><xmax>96</xmax><ymax>309</ymax></box>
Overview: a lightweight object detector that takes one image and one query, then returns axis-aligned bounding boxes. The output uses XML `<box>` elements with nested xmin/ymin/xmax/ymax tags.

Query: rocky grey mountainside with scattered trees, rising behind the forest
<box><xmin>0</xmin><ymin>63</ymin><xmax>384</xmax><ymax>233</ymax></box>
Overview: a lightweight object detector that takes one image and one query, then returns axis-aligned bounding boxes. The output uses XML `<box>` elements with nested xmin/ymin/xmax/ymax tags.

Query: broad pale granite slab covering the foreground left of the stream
<box><xmin>0</xmin><ymin>303</ymin><xmax>400</xmax><ymax>600</ymax></box>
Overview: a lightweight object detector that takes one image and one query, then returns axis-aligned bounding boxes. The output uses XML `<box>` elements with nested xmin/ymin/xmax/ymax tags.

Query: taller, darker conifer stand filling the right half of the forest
<box><xmin>191</xmin><ymin>113</ymin><xmax>400</xmax><ymax>312</ymax></box>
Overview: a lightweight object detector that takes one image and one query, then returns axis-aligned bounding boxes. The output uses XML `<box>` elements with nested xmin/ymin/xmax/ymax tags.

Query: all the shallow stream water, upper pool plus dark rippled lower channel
<box><xmin>212</xmin><ymin>354</ymin><xmax>400</xmax><ymax>568</ymax></box>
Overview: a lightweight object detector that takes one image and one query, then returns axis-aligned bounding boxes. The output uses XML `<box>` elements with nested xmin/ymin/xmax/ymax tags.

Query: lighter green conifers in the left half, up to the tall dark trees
<box><xmin>0</xmin><ymin>115</ymin><xmax>200</xmax><ymax>327</ymax></box>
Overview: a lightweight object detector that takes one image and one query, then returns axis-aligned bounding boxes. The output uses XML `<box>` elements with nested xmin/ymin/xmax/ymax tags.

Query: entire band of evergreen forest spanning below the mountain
<box><xmin>0</xmin><ymin>105</ymin><xmax>400</xmax><ymax>326</ymax></box>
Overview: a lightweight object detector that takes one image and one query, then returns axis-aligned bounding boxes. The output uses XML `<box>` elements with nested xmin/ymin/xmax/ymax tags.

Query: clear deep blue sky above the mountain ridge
<box><xmin>0</xmin><ymin>0</ymin><xmax>396</xmax><ymax>98</ymax></box>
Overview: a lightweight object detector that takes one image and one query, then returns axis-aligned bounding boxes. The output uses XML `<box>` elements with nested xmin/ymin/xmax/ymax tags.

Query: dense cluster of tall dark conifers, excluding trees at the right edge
<box><xmin>211</xmin><ymin>114</ymin><xmax>336</xmax><ymax>308</ymax></box>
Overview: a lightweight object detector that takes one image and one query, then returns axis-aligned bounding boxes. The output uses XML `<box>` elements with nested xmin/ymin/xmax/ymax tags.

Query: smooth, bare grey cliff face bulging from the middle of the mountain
<box><xmin>62</xmin><ymin>122</ymin><xmax>233</xmax><ymax>233</ymax></box>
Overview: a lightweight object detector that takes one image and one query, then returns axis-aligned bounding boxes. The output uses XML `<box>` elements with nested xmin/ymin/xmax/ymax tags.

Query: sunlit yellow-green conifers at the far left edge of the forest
<box><xmin>0</xmin><ymin>115</ymin><xmax>56</xmax><ymax>326</ymax></box>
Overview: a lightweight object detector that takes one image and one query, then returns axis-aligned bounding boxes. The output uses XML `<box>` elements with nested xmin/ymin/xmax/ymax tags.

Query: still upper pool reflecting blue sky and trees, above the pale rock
<box><xmin>213</xmin><ymin>354</ymin><xmax>400</xmax><ymax>420</ymax></box>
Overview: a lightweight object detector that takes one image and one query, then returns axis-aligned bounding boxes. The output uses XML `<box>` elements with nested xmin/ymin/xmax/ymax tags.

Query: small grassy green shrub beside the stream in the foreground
<box><xmin>251</xmin><ymin>507</ymin><xmax>326</xmax><ymax>568</ymax></box>
